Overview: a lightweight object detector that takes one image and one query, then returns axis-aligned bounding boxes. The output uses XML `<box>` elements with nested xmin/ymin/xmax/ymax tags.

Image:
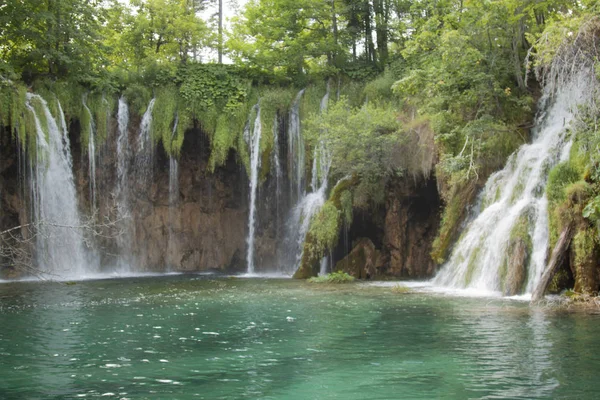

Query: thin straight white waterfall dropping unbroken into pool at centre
<box><xmin>246</xmin><ymin>104</ymin><xmax>262</xmax><ymax>274</ymax></box>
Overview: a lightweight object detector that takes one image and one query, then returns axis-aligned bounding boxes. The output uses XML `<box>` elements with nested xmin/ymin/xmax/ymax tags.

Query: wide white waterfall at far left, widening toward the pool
<box><xmin>25</xmin><ymin>93</ymin><xmax>93</xmax><ymax>279</ymax></box>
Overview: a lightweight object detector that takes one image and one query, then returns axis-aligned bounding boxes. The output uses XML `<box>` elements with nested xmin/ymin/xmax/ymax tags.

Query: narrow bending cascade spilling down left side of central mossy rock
<box><xmin>287</xmin><ymin>85</ymin><xmax>332</xmax><ymax>268</ymax></box>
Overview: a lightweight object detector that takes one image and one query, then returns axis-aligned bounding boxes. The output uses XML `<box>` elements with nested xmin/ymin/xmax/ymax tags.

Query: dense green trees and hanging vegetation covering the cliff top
<box><xmin>0</xmin><ymin>0</ymin><xmax>600</xmax><ymax>292</ymax></box>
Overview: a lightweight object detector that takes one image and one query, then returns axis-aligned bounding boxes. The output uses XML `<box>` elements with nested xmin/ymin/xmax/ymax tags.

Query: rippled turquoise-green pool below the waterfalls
<box><xmin>0</xmin><ymin>276</ymin><xmax>600</xmax><ymax>399</ymax></box>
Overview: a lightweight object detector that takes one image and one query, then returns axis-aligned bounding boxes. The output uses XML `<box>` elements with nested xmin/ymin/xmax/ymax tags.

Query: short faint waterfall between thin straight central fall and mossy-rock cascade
<box><xmin>288</xmin><ymin>89</ymin><xmax>305</xmax><ymax>203</ymax></box>
